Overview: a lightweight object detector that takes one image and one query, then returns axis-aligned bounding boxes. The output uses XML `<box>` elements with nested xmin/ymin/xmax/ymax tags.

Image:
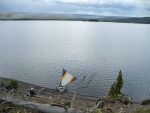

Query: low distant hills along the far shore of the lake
<box><xmin>0</xmin><ymin>11</ymin><xmax>150</xmax><ymax>24</ymax></box>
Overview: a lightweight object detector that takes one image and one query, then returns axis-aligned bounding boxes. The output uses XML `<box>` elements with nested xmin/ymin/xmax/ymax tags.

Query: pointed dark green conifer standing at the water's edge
<box><xmin>108</xmin><ymin>70</ymin><xmax>123</xmax><ymax>98</ymax></box>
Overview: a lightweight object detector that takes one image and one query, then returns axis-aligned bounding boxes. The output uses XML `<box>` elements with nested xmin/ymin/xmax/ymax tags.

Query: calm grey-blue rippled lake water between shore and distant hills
<box><xmin>0</xmin><ymin>21</ymin><xmax>150</xmax><ymax>101</ymax></box>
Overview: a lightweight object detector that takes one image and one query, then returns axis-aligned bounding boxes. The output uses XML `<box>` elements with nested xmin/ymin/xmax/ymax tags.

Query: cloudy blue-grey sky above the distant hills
<box><xmin>0</xmin><ymin>0</ymin><xmax>150</xmax><ymax>17</ymax></box>
